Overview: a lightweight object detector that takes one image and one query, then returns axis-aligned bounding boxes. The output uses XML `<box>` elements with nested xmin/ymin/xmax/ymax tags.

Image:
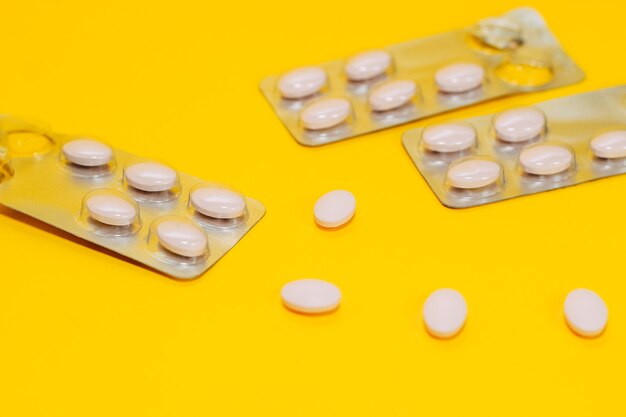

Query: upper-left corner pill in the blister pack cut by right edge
<box><xmin>422</xmin><ymin>123</ymin><xmax>476</xmax><ymax>153</ymax></box>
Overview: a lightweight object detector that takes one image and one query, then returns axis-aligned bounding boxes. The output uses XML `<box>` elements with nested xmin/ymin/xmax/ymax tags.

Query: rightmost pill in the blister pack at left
<box><xmin>190</xmin><ymin>187</ymin><xmax>246</xmax><ymax>219</ymax></box>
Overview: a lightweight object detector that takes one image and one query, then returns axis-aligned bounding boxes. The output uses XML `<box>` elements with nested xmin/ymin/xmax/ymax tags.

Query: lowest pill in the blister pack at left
<box><xmin>156</xmin><ymin>220</ymin><xmax>208</xmax><ymax>257</ymax></box>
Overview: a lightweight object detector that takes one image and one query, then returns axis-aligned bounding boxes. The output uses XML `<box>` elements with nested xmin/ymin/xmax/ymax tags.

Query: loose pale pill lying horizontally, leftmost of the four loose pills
<box><xmin>280</xmin><ymin>279</ymin><xmax>341</xmax><ymax>314</ymax></box>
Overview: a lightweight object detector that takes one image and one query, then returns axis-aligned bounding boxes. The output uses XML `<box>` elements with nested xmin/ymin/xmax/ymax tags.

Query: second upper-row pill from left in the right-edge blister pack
<box><xmin>494</xmin><ymin>108</ymin><xmax>546</xmax><ymax>142</ymax></box>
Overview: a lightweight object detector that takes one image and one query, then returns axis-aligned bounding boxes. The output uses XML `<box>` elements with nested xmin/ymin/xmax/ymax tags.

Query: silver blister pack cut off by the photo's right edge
<box><xmin>402</xmin><ymin>86</ymin><xmax>626</xmax><ymax>208</ymax></box>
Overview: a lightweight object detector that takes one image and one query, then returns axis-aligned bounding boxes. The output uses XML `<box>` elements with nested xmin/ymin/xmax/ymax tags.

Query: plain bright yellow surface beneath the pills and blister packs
<box><xmin>0</xmin><ymin>0</ymin><xmax>626</xmax><ymax>417</ymax></box>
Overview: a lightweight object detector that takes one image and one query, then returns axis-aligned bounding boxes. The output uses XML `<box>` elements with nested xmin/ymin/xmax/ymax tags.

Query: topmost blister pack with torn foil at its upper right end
<box><xmin>261</xmin><ymin>8</ymin><xmax>584</xmax><ymax>146</ymax></box>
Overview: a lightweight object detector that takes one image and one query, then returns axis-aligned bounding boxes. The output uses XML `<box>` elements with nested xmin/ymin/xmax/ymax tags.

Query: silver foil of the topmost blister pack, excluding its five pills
<box><xmin>260</xmin><ymin>8</ymin><xmax>584</xmax><ymax>146</ymax></box>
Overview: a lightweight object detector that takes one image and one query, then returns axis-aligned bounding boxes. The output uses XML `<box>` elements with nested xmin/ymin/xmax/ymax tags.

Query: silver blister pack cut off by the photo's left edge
<box><xmin>0</xmin><ymin>116</ymin><xmax>265</xmax><ymax>279</ymax></box>
